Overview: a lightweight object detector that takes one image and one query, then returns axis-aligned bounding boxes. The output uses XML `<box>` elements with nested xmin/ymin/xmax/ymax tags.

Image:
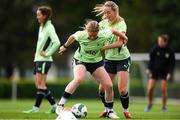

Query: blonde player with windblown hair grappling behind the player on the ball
<box><xmin>94</xmin><ymin>1</ymin><xmax>131</xmax><ymax>118</ymax></box>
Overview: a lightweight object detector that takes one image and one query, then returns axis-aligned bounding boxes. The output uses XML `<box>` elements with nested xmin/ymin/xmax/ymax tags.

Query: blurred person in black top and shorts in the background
<box><xmin>144</xmin><ymin>34</ymin><xmax>175</xmax><ymax>112</ymax></box>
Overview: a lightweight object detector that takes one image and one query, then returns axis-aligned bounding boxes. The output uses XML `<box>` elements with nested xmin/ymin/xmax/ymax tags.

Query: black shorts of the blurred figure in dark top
<box><xmin>151</xmin><ymin>71</ymin><xmax>168</xmax><ymax>80</ymax></box>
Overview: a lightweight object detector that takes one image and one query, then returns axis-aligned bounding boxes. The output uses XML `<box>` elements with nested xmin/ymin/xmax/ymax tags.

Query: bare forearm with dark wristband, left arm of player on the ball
<box><xmin>59</xmin><ymin>35</ymin><xmax>75</xmax><ymax>54</ymax></box>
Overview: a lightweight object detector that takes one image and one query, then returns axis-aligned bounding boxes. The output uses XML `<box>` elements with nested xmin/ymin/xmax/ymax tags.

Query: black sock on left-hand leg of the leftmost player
<box><xmin>34</xmin><ymin>89</ymin><xmax>45</xmax><ymax>108</ymax></box>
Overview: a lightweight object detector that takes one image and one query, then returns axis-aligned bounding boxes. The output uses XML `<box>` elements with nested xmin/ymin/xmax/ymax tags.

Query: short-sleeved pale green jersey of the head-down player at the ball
<box><xmin>73</xmin><ymin>29</ymin><xmax>112</xmax><ymax>63</ymax></box>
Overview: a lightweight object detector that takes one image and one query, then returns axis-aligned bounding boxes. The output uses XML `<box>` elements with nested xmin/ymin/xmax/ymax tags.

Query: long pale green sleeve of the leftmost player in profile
<box><xmin>46</xmin><ymin>26</ymin><xmax>60</xmax><ymax>56</ymax></box>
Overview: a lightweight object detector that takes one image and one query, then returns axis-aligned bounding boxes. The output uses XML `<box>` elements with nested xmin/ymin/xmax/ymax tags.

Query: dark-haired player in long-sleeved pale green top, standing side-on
<box><xmin>23</xmin><ymin>6</ymin><xmax>60</xmax><ymax>113</ymax></box>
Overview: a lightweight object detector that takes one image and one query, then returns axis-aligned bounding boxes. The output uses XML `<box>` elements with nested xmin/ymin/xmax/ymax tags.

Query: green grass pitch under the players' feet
<box><xmin>0</xmin><ymin>99</ymin><xmax>180</xmax><ymax>120</ymax></box>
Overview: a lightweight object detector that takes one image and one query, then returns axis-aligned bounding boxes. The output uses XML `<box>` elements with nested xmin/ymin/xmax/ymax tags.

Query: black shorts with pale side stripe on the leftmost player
<box><xmin>34</xmin><ymin>61</ymin><xmax>52</xmax><ymax>75</ymax></box>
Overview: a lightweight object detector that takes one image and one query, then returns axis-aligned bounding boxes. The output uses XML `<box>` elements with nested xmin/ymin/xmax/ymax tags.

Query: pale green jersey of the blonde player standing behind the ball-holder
<box><xmin>99</xmin><ymin>19</ymin><xmax>130</xmax><ymax>60</ymax></box>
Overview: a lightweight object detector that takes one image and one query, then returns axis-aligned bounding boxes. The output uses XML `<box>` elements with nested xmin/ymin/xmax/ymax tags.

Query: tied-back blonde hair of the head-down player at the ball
<box><xmin>83</xmin><ymin>20</ymin><xmax>99</xmax><ymax>32</ymax></box>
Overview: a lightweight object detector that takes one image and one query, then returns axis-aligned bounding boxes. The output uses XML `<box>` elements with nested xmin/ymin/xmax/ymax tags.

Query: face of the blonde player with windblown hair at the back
<box><xmin>104</xmin><ymin>7</ymin><xmax>116</xmax><ymax>21</ymax></box>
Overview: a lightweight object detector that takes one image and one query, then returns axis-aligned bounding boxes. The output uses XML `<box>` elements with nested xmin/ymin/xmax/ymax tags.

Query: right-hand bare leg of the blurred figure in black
<box><xmin>161</xmin><ymin>79</ymin><xmax>167</xmax><ymax>112</ymax></box>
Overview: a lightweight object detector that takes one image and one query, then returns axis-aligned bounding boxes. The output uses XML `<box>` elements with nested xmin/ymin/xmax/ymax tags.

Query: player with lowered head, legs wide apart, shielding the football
<box><xmin>56</xmin><ymin>20</ymin><xmax>127</xmax><ymax>119</ymax></box>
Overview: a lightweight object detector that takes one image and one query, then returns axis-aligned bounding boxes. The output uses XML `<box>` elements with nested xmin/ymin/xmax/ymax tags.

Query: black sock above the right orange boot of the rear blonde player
<box><xmin>120</xmin><ymin>92</ymin><xmax>129</xmax><ymax>111</ymax></box>
